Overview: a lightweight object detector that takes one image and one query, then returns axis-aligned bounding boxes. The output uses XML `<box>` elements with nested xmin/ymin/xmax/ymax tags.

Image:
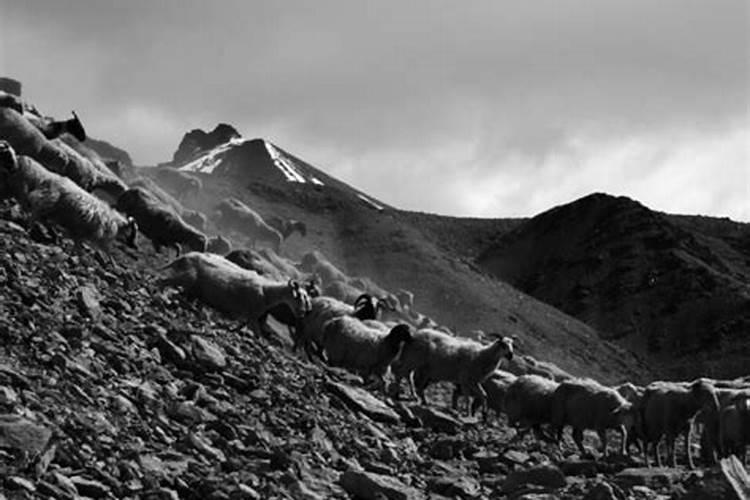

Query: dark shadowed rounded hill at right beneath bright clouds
<box><xmin>477</xmin><ymin>194</ymin><xmax>750</xmax><ymax>378</ymax></box>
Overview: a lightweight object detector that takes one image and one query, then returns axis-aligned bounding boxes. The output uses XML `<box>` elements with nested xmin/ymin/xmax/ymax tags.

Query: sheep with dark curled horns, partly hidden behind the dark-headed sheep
<box><xmin>293</xmin><ymin>294</ymin><xmax>379</xmax><ymax>360</ymax></box>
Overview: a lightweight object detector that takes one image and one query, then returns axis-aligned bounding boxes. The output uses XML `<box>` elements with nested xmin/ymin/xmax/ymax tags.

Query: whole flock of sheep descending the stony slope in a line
<box><xmin>0</xmin><ymin>92</ymin><xmax>750</xmax><ymax>474</ymax></box>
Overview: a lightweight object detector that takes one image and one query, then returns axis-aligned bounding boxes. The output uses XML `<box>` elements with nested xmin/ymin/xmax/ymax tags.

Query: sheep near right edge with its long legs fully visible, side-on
<box><xmin>640</xmin><ymin>379</ymin><xmax>721</xmax><ymax>469</ymax></box>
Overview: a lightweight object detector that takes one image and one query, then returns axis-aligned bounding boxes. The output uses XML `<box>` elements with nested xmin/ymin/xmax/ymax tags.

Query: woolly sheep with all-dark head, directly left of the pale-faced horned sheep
<box><xmin>323</xmin><ymin>316</ymin><xmax>411</xmax><ymax>389</ymax></box>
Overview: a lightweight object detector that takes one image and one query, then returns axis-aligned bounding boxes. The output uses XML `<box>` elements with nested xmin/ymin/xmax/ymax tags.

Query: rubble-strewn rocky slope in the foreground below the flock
<box><xmin>0</xmin><ymin>205</ymin><xmax>744</xmax><ymax>500</ymax></box>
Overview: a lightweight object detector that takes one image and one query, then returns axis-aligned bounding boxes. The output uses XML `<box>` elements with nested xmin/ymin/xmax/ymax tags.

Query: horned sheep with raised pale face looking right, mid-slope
<box><xmin>393</xmin><ymin>329</ymin><xmax>513</xmax><ymax>411</ymax></box>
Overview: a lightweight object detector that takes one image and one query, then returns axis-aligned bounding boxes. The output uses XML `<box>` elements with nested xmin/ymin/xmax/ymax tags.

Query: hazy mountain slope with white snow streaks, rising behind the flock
<box><xmin>157</xmin><ymin>129</ymin><xmax>654</xmax><ymax>383</ymax></box>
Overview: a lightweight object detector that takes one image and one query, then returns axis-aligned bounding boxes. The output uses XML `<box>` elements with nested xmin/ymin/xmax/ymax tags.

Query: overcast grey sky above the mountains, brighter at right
<box><xmin>0</xmin><ymin>0</ymin><xmax>750</xmax><ymax>221</ymax></box>
